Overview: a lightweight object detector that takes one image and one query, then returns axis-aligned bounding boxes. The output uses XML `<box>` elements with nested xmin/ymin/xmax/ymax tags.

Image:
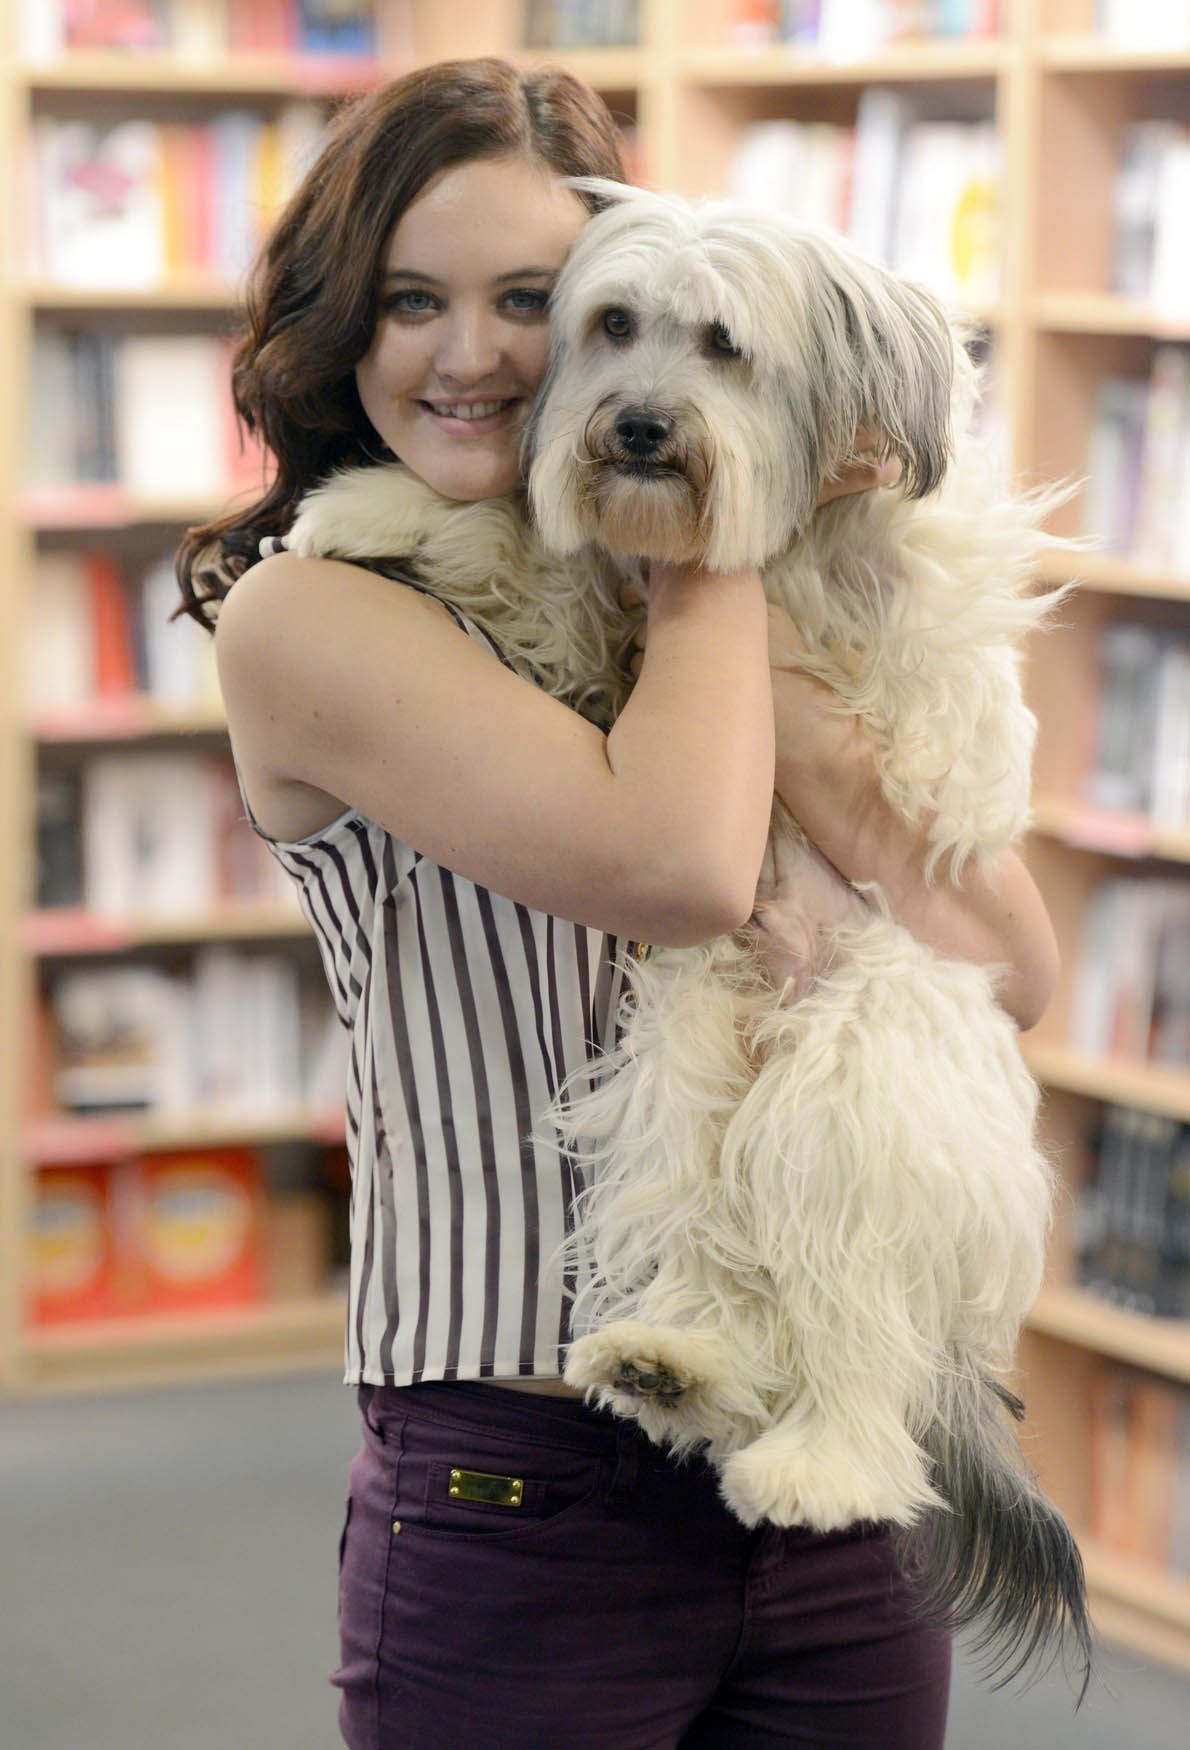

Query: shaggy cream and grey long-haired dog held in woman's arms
<box><xmin>281</xmin><ymin>180</ymin><xmax>1089</xmax><ymax>1675</ymax></box>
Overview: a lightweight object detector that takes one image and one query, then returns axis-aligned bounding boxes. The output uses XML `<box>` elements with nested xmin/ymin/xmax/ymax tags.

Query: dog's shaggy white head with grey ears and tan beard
<box><xmin>523</xmin><ymin>179</ymin><xmax>966</xmax><ymax>571</ymax></box>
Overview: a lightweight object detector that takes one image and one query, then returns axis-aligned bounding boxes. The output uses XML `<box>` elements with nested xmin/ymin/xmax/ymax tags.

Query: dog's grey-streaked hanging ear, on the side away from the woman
<box><xmin>828</xmin><ymin>245</ymin><xmax>957</xmax><ymax>499</ymax></box>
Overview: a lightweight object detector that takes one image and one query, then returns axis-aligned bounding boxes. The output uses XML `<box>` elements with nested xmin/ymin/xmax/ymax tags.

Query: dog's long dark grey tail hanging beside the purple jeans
<box><xmin>896</xmin><ymin>1358</ymin><xmax>1092</xmax><ymax>1708</ymax></box>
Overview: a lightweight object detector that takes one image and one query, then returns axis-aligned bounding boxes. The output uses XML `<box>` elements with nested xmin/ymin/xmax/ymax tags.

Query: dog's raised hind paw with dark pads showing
<box><xmin>564</xmin><ymin>1320</ymin><xmax>728</xmax><ymax>1409</ymax></box>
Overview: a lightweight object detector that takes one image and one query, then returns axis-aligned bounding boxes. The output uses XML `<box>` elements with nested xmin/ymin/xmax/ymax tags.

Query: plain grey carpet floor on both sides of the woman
<box><xmin>0</xmin><ymin>1376</ymin><xmax>1190</xmax><ymax>1750</ymax></box>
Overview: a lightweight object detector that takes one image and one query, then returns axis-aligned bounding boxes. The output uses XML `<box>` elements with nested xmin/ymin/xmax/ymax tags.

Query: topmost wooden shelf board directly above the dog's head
<box><xmin>677</xmin><ymin>42</ymin><xmax>1013</xmax><ymax>88</ymax></box>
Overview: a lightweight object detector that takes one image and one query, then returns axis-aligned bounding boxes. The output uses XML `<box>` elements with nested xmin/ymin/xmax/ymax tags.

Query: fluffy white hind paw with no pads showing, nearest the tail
<box><xmin>719</xmin><ymin>1430</ymin><xmax>938</xmax><ymax>1531</ymax></box>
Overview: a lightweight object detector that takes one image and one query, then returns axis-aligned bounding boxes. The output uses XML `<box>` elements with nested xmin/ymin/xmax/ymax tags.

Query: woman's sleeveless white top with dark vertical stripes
<box><xmin>231</xmin><ymin>562</ymin><xmax>637</xmax><ymax>1386</ymax></box>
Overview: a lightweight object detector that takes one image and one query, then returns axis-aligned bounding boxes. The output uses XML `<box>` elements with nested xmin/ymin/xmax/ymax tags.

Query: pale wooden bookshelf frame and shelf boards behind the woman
<box><xmin>0</xmin><ymin>0</ymin><xmax>1190</xmax><ymax>1668</ymax></box>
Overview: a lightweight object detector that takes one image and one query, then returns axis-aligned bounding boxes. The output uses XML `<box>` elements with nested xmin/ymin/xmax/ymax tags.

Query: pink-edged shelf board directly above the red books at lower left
<box><xmin>23</xmin><ymin>1110</ymin><xmax>347</xmax><ymax>1167</ymax></box>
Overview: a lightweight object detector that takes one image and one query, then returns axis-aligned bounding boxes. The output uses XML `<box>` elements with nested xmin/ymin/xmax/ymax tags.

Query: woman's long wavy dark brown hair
<box><xmin>170</xmin><ymin>58</ymin><xmax>627</xmax><ymax>632</ymax></box>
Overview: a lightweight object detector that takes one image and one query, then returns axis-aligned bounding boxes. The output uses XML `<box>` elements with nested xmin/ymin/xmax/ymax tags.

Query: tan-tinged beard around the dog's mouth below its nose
<box><xmin>579</xmin><ymin>410</ymin><xmax>711</xmax><ymax>564</ymax></box>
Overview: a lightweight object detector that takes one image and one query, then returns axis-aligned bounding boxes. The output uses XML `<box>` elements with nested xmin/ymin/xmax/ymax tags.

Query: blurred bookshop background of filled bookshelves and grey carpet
<box><xmin>0</xmin><ymin>0</ymin><xmax>1190</xmax><ymax>1750</ymax></box>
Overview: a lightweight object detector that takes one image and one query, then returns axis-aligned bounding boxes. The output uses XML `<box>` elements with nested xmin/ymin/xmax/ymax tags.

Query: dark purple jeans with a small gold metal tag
<box><xmin>331</xmin><ymin>1381</ymin><xmax>950</xmax><ymax>1750</ymax></box>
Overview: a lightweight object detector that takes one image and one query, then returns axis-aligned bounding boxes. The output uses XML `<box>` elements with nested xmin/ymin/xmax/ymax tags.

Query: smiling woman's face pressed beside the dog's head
<box><xmin>355</xmin><ymin>158</ymin><xmax>588</xmax><ymax>501</ymax></box>
